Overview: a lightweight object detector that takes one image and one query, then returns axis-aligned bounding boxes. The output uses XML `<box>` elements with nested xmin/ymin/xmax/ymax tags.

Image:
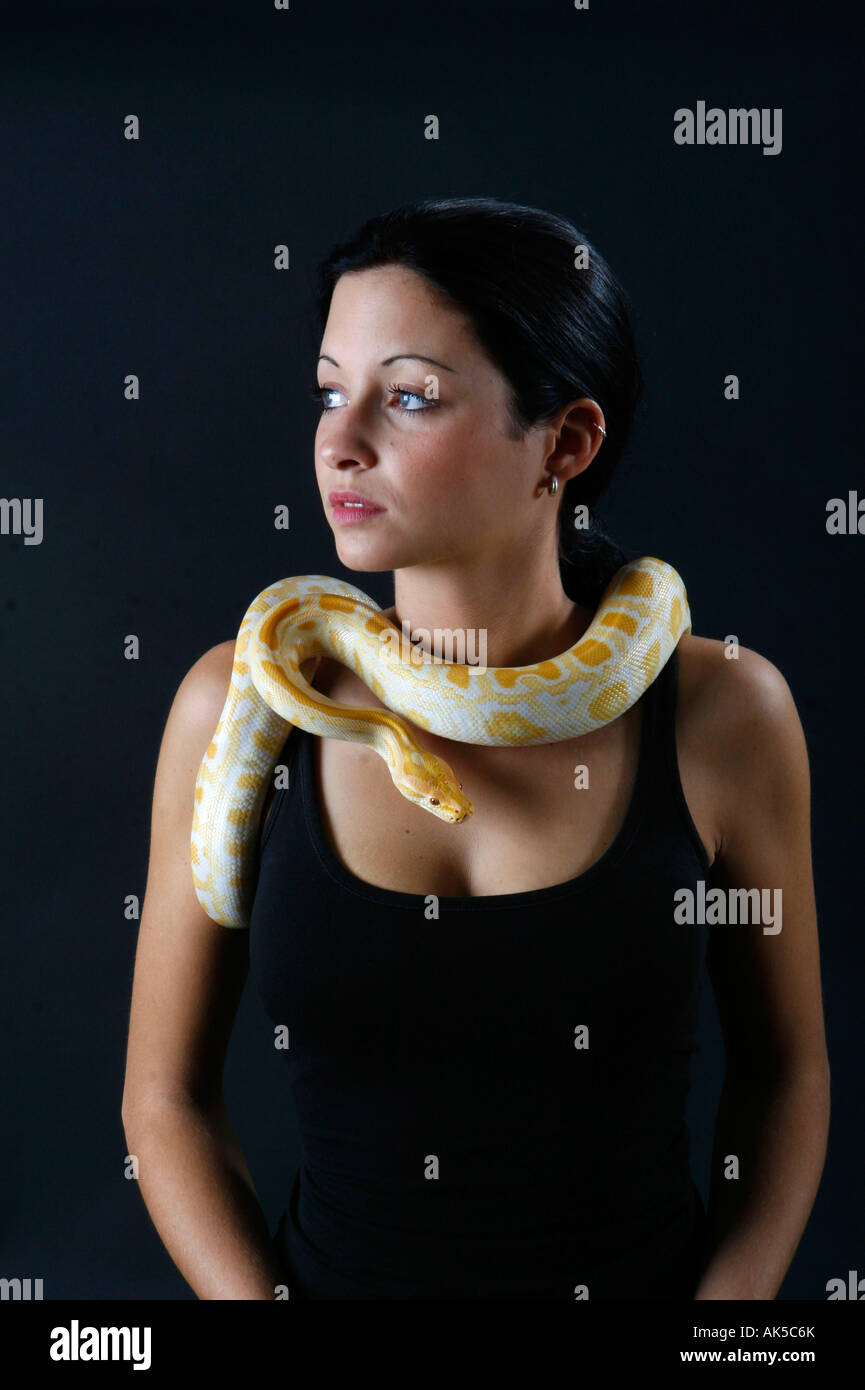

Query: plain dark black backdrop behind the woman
<box><xmin>0</xmin><ymin>0</ymin><xmax>865</xmax><ymax>1300</ymax></box>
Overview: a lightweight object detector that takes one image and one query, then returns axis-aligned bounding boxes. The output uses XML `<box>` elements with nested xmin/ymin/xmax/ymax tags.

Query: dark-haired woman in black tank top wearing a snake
<box><xmin>124</xmin><ymin>199</ymin><xmax>829</xmax><ymax>1300</ymax></box>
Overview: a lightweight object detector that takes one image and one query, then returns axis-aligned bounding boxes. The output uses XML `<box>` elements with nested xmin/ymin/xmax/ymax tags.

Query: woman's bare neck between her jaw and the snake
<box><xmin>385</xmin><ymin>547</ymin><xmax>592</xmax><ymax>667</ymax></box>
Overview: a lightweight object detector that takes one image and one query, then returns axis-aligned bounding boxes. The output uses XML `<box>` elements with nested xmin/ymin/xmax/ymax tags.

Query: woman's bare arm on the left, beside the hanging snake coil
<box><xmin>122</xmin><ymin>642</ymin><xmax>286</xmax><ymax>1300</ymax></box>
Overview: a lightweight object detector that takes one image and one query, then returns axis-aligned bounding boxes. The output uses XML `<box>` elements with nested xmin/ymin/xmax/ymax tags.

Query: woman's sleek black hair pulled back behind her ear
<box><xmin>317</xmin><ymin>197</ymin><xmax>642</xmax><ymax>609</ymax></box>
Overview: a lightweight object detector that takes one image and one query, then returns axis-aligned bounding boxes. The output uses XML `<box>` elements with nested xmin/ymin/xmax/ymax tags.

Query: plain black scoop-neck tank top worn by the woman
<box><xmin>250</xmin><ymin>652</ymin><xmax>708</xmax><ymax>1301</ymax></box>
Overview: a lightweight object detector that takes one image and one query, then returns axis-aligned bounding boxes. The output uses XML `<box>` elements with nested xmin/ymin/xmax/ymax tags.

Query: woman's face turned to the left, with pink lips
<box><xmin>316</xmin><ymin>265</ymin><xmax>552</xmax><ymax>570</ymax></box>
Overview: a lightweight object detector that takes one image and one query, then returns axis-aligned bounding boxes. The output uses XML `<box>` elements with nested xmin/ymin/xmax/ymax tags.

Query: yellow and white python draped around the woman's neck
<box><xmin>191</xmin><ymin>556</ymin><xmax>691</xmax><ymax>927</ymax></box>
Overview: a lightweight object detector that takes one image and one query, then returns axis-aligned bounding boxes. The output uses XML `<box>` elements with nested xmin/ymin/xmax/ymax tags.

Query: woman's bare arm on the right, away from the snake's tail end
<box><xmin>694</xmin><ymin>649</ymin><xmax>830</xmax><ymax>1300</ymax></box>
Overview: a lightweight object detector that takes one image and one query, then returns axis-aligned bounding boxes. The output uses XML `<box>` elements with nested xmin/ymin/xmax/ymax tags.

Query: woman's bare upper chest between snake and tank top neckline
<box><xmin>312</xmin><ymin>709</ymin><xmax>653</xmax><ymax>897</ymax></box>
